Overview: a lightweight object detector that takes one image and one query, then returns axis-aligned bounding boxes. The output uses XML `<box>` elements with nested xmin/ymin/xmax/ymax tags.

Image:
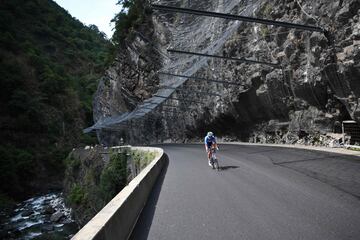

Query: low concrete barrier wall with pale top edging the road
<box><xmin>72</xmin><ymin>147</ymin><xmax>168</xmax><ymax>240</ymax></box>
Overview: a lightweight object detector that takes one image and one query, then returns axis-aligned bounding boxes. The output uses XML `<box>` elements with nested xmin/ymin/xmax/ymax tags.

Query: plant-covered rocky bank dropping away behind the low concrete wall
<box><xmin>64</xmin><ymin>146</ymin><xmax>157</xmax><ymax>226</ymax></box>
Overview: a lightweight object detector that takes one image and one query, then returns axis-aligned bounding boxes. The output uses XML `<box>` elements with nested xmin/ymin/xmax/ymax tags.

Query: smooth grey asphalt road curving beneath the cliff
<box><xmin>131</xmin><ymin>145</ymin><xmax>360</xmax><ymax>240</ymax></box>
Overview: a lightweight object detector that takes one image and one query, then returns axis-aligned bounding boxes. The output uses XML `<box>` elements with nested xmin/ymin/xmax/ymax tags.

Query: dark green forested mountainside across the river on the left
<box><xmin>0</xmin><ymin>0</ymin><xmax>110</xmax><ymax>202</ymax></box>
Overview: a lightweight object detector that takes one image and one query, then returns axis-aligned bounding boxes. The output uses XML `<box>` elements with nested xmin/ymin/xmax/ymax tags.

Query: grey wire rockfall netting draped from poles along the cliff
<box><xmin>84</xmin><ymin>0</ymin><xmax>263</xmax><ymax>132</ymax></box>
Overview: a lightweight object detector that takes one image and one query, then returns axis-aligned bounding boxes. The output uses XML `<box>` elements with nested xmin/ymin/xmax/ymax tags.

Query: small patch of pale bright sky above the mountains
<box><xmin>55</xmin><ymin>0</ymin><xmax>121</xmax><ymax>38</ymax></box>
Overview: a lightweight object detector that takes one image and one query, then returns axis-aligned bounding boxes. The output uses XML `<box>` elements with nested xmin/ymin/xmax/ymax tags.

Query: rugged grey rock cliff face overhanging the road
<box><xmin>94</xmin><ymin>0</ymin><xmax>360</xmax><ymax>145</ymax></box>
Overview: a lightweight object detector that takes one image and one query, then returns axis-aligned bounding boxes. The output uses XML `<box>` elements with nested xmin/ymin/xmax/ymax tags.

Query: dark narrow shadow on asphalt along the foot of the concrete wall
<box><xmin>129</xmin><ymin>156</ymin><xmax>169</xmax><ymax>240</ymax></box>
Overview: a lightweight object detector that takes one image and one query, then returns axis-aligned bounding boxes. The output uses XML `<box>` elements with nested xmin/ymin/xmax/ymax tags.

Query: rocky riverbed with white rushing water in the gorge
<box><xmin>0</xmin><ymin>193</ymin><xmax>78</xmax><ymax>240</ymax></box>
